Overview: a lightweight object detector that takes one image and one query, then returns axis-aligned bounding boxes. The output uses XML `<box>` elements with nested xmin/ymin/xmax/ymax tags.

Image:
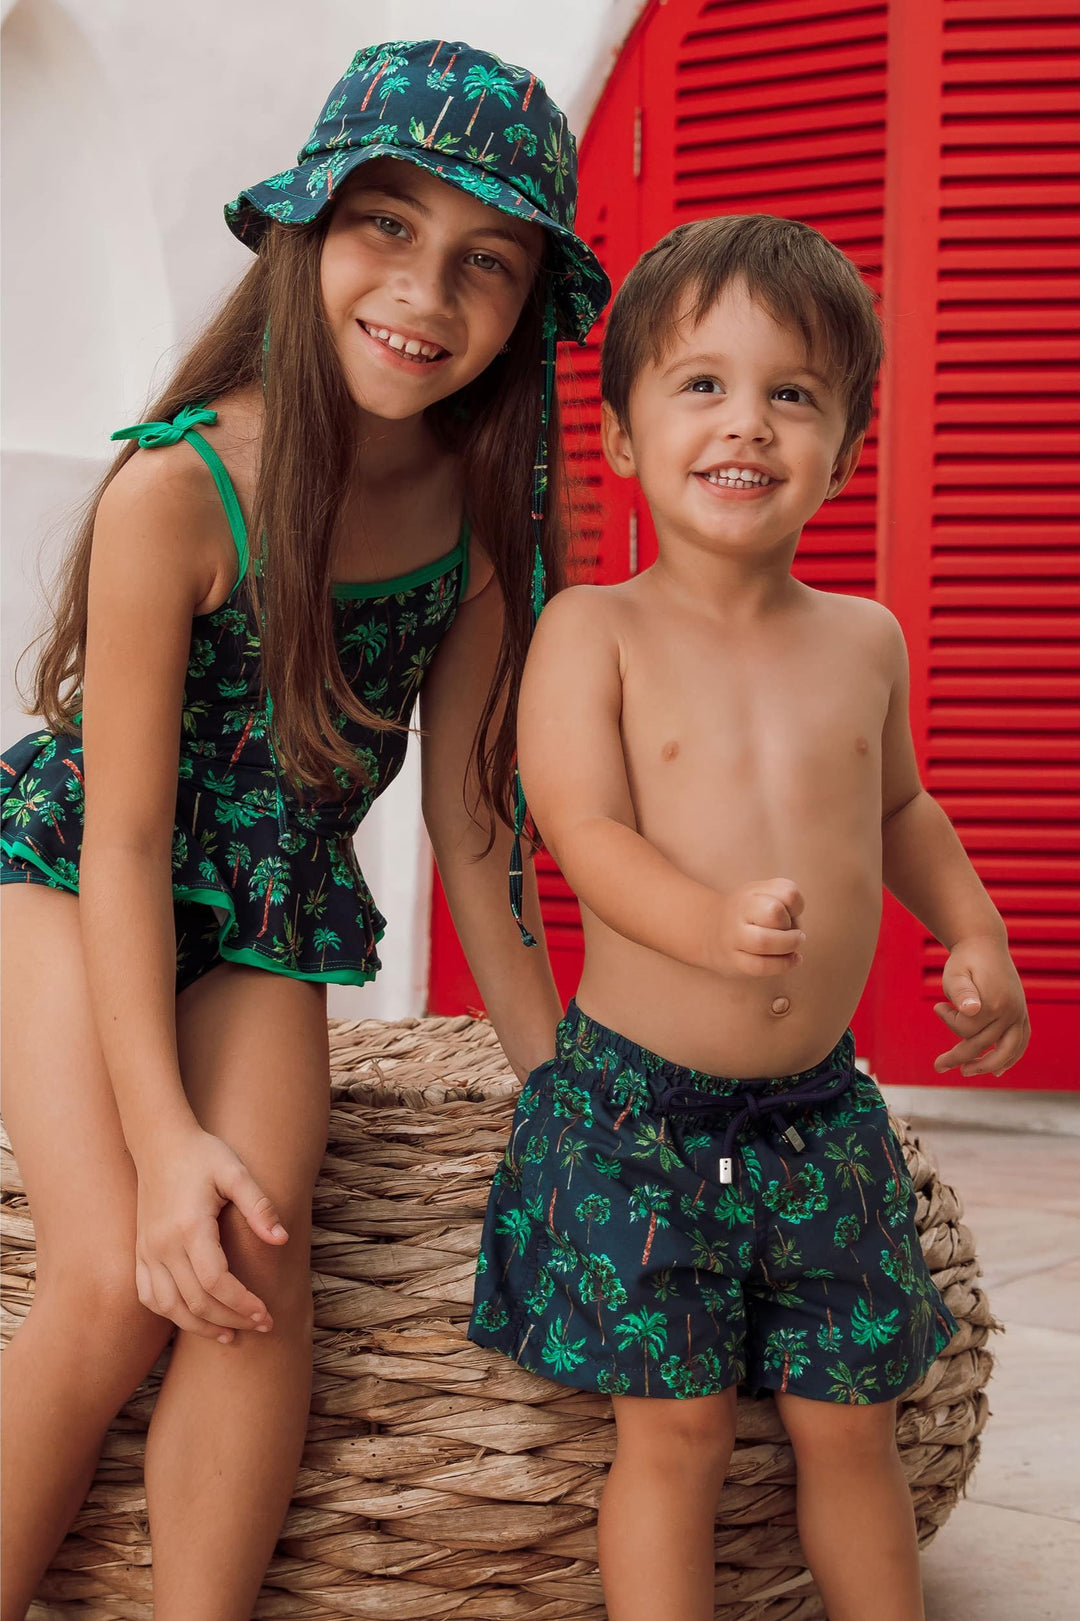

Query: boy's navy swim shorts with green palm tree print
<box><xmin>469</xmin><ymin>1002</ymin><xmax>957</xmax><ymax>1402</ymax></box>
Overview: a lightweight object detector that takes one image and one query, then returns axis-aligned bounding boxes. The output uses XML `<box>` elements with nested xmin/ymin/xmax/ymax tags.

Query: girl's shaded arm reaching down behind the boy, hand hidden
<box><xmin>420</xmin><ymin>557</ymin><xmax>563</xmax><ymax>1078</ymax></box>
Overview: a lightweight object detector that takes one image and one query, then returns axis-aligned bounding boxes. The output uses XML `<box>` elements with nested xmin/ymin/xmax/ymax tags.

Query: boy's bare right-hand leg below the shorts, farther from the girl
<box><xmin>777</xmin><ymin>1394</ymin><xmax>924</xmax><ymax>1621</ymax></box>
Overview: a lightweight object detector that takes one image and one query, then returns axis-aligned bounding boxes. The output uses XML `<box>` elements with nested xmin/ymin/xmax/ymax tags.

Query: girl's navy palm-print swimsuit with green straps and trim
<box><xmin>0</xmin><ymin>405</ymin><xmax>469</xmax><ymax>990</ymax></box>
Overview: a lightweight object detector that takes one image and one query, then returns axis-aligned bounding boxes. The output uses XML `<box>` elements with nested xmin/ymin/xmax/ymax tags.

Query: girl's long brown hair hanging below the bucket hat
<box><xmin>31</xmin><ymin>219</ymin><xmax>564</xmax><ymax>832</ymax></box>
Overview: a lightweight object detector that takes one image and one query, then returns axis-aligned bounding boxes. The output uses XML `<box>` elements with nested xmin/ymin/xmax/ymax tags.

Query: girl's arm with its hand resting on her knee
<box><xmin>79</xmin><ymin>446</ymin><xmax>284</xmax><ymax>1337</ymax></box>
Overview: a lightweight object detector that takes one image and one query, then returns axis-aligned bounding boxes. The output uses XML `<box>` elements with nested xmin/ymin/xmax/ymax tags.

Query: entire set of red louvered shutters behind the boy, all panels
<box><xmin>433</xmin><ymin>0</ymin><xmax>1080</xmax><ymax>1086</ymax></box>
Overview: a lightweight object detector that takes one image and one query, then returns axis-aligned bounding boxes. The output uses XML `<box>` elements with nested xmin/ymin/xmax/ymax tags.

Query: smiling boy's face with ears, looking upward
<box><xmin>603</xmin><ymin>284</ymin><xmax>863</xmax><ymax>558</ymax></box>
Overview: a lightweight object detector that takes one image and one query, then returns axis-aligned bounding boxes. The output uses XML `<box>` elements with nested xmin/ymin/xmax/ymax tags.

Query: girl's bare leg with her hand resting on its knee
<box><xmin>146</xmin><ymin>966</ymin><xmax>329</xmax><ymax>1621</ymax></box>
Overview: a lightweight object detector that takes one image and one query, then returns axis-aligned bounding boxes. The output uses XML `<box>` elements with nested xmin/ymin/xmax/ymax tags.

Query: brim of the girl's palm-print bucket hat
<box><xmin>225</xmin><ymin>141</ymin><xmax>611</xmax><ymax>344</ymax></box>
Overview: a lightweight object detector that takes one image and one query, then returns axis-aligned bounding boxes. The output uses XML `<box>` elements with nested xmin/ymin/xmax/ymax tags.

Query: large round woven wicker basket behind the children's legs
<box><xmin>2</xmin><ymin>1018</ymin><xmax>994</xmax><ymax>1621</ymax></box>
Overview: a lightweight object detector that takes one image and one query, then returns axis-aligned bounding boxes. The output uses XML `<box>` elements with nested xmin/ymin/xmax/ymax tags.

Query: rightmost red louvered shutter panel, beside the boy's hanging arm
<box><xmin>871</xmin><ymin>0</ymin><xmax>1080</xmax><ymax>1088</ymax></box>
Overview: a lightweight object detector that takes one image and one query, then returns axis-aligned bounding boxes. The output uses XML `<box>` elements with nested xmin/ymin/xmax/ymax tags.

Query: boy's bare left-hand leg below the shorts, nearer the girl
<box><xmin>598</xmin><ymin>1388</ymin><xmax>735</xmax><ymax>1621</ymax></box>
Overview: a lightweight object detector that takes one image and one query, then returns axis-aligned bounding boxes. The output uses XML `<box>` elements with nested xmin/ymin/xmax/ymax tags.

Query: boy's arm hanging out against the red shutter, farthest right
<box><xmin>881</xmin><ymin>614</ymin><xmax>1031</xmax><ymax>1075</ymax></box>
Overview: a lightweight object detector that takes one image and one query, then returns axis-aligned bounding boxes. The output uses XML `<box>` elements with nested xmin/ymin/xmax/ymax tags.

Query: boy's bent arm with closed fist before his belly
<box><xmin>517</xmin><ymin>587</ymin><xmax>803</xmax><ymax>974</ymax></box>
